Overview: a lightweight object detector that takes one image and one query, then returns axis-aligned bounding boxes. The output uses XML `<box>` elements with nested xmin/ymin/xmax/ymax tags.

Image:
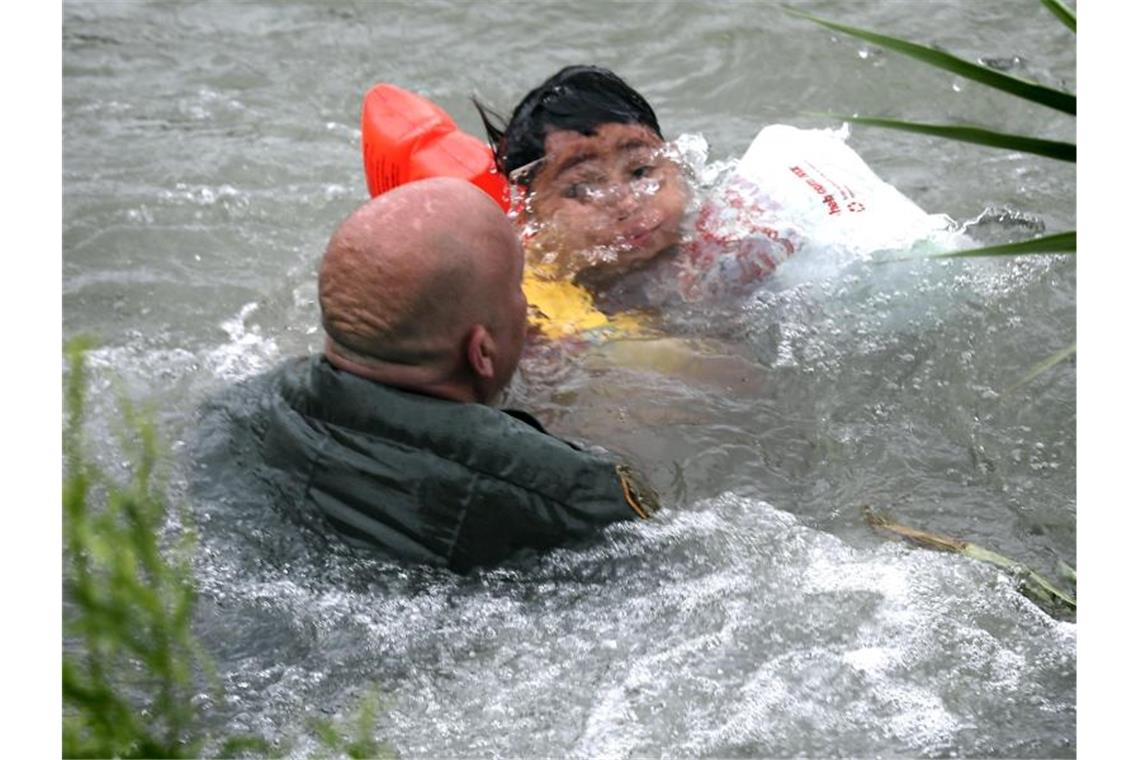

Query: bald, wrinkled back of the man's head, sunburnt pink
<box><xmin>319</xmin><ymin>178</ymin><xmax>524</xmax><ymax>403</ymax></box>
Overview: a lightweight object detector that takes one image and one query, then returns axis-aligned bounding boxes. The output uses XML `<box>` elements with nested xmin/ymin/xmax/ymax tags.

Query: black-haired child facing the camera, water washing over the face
<box><xmin>475</xmin><ymin>66</ymin><xmax>797</xmax><ymax>335</ymax></box>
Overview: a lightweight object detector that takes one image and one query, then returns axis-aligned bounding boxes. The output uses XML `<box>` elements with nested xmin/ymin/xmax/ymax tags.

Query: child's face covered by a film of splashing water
<box><xmin>519</xmin><ymin>123</ymin><xmax>689</xmax><ymax>285</ymax></box>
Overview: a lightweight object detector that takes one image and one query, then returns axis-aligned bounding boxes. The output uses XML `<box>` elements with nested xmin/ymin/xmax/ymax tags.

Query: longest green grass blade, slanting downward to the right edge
<box><xmin>784</xmin><ymin>8</ymin><xmax>1076</xmax><ymax>114</ymax></box>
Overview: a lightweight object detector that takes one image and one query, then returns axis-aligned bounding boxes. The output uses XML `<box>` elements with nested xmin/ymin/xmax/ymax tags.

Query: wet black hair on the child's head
<box><xmin>474</xmin><ymin>66</ymin><xmax>661</xmax><ymax>185</ymax></box>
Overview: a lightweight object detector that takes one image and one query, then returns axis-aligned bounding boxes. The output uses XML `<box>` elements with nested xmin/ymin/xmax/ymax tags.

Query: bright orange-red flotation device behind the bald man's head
<box><xmin>360</xmin><ymin>84</ymin><xmax>511</xmax><ymax>211</ymax></box>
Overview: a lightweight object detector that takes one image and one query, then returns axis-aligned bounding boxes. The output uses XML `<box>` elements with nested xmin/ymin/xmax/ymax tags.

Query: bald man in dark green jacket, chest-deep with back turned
<box><xmin>253</xmin><ymin>179</ymin><xmax>657</xmax><ymax>571</ymax></box>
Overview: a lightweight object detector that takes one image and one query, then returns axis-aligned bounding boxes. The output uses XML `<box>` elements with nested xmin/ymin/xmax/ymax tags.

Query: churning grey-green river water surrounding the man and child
<box><xmin>63</xmin><ymin>0</ymin><xmax>1076</xmax><ymax>757</ymax></box>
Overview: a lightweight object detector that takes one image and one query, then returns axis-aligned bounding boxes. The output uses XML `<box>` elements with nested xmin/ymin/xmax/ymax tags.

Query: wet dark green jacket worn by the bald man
<box><xmin>262</xmin><ymin>357</ymin><xmax>657</xmax><ymax>571</ymax></box>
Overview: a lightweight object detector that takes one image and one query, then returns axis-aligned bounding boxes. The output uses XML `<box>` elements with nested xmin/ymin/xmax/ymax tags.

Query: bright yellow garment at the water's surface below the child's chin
<box><xmin>522</xmin><ymin>267</ymin><xmax>643</xmax><ymax>340</ymax></box>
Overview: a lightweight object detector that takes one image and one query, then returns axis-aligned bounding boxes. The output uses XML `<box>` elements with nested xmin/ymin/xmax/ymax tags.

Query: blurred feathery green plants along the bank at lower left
<box><xmin>63</xmin><ymin>340</ymin><xmax>394</xmax><ymax>758</ymax></box>
